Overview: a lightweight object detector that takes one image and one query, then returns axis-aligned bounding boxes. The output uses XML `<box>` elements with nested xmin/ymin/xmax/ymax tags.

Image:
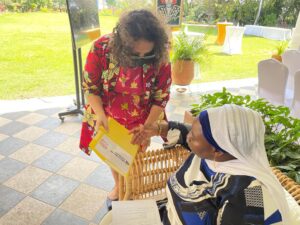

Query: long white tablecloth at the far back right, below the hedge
<box><xmin>245</xmin><ymin>25</ymin><xmax>292</xmax><ymax>41</ymax></box>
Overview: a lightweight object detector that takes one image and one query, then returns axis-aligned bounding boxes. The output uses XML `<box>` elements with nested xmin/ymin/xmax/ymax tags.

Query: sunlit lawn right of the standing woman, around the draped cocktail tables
<box><xmin>189</xmin><ymin>26</ymin><xmax>279</xmax><ymax>82</ymax></box>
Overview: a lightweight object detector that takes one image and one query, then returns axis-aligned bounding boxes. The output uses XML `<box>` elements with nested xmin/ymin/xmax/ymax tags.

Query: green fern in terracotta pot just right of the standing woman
<box><xmin>171</xmin><ymin>31</ymin><xmax>208</xmax><ymax>85</ymax></box>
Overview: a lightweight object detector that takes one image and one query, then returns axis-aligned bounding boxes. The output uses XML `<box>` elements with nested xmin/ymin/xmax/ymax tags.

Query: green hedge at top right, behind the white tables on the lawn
<box><xmin>185</xmin><ymin>0</ymin><xmax>300</xmax><ymax>27</ymax></box>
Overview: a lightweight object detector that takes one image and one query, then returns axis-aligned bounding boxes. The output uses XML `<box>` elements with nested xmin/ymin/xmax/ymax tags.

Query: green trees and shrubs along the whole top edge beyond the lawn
<box><xmin>0</xmin><ymin>0</ymin><xmax>300</xmax><ymax>27</ymax></box>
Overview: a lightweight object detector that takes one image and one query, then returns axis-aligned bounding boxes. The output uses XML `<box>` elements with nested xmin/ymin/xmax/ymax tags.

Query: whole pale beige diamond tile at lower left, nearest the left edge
<box><xmin>3</xmin><ymin>166</ymin><xmax>52</xmax><ymax>194</ymax></box>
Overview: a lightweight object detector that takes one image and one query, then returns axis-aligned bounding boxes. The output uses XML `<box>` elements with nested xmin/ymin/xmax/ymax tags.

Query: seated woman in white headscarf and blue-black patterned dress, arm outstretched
<box><xmin>131</xmin><ymin>105</ymin><xmax>294</xmax><ymax>225</ymax></box>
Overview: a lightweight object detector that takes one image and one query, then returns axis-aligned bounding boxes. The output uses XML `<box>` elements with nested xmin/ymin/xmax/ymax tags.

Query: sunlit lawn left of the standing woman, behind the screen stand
<box><xmin>0</xmin><ymin>12</ymin><xmax>117</xmax><ymax>99</ymax></box>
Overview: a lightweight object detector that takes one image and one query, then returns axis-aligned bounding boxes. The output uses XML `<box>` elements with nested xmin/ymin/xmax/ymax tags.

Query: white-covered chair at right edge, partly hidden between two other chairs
<box><xmin>282</xmin><ymin>50</ymin><xmax>300</xmax><ymax>100</ymax></box>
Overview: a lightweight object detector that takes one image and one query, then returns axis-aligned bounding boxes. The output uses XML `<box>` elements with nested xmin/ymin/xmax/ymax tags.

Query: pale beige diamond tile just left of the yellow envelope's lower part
<box><xmin>57</xmin><ymin>157</ymin><xmax>98</xmax><ymax>181</ymax></box>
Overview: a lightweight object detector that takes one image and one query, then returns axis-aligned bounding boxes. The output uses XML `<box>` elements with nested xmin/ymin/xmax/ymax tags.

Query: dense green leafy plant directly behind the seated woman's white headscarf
<box><xmin>191</xmin><ymin>88</ymin><xmax>300</xmax><ymax>183</ymax></box>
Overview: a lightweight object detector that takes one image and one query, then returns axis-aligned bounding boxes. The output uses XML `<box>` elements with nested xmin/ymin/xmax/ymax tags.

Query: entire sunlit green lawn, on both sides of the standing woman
<box><xmin>0</xmin><ymin>13</ymin><xmax>276</xmax><ymax>99</ymax></box>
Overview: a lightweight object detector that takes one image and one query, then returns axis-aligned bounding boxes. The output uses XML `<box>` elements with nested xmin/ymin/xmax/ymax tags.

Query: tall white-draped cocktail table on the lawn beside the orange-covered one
<box><xmin>223</xmin><ymin>26</ymin><xmax>245</xmax><ymax>55</ymax></box>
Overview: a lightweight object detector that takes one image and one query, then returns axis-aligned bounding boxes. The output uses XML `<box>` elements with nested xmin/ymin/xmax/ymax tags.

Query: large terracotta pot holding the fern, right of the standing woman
<box><xmin>172</xmin><ymin>60</ymin><xmax>194</xmax><ymax>85</ymax></box>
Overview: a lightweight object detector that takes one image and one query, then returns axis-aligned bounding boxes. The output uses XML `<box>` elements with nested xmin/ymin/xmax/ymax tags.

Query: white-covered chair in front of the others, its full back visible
<box><xmin>258</xmin><ymin>59</ymin><xmax>289</xmax><ymax>105</ymax></box>
